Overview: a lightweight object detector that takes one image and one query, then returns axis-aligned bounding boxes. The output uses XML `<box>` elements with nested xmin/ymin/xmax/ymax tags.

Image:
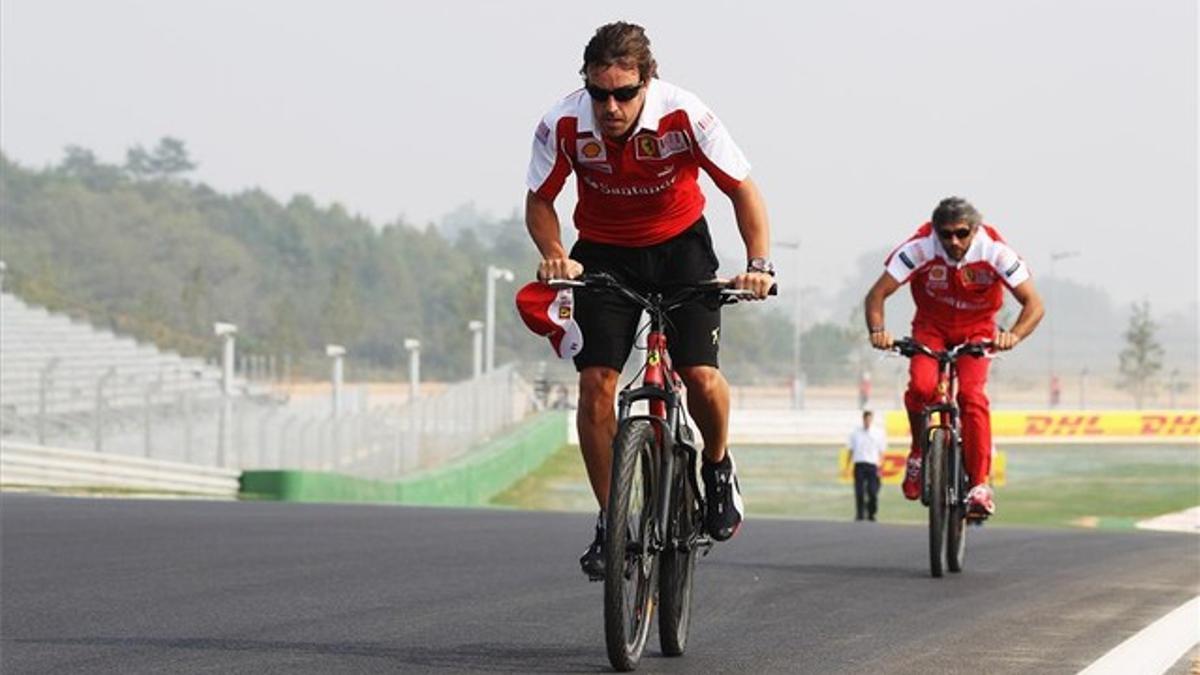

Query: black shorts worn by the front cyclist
<box><xmin>571</xmin><ymin>216</ymin><xmax>721</xmax><ymax>371</ymax></box>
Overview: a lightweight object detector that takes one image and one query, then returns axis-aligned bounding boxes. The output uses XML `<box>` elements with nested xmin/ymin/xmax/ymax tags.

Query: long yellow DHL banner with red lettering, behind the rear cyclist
<box><xmin>886</xmin><ymin>411</ymin><xmax>1200</xmax><ymax>443</ymax></box>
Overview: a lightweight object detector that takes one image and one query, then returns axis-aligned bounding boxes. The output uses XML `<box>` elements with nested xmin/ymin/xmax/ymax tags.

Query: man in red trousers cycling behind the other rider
<box><xmin>865</xmin><ymin>197</ymin><xmax>1045</xmax><ymax>516</ymax></box>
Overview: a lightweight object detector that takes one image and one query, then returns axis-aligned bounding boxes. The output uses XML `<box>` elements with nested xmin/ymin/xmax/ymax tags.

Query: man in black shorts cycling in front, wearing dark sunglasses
<box><xmin>526</xmin><ymin>22</ymin><xmax>774</xmax><ymax>579</ymax></box>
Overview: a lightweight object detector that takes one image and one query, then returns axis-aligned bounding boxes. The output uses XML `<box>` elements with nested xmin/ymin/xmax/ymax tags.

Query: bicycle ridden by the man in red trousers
<box><xmin>892</xmin><ymin>338</ymin><xmax>992</xmax><ymax>578</ymax></box>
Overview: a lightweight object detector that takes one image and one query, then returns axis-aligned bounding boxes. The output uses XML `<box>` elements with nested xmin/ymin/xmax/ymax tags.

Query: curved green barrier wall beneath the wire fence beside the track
<box><xmin>240</xmin><ymin>411</ymin><xmax>568</xmax><ymax>506</ymax></box>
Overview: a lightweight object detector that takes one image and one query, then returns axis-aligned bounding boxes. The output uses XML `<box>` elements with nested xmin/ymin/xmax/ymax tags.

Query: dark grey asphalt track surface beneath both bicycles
<box><xmin>0</xmin><ymin>494</ymin><xmax>1200</xmax><ymax>674</ymax></box>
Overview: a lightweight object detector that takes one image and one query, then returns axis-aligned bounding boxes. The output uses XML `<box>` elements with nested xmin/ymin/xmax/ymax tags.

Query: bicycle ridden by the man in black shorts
<box><xmin>550</xmin><ymin>274</ymin><xmax>776</xmax><ymax>671</ymax></box>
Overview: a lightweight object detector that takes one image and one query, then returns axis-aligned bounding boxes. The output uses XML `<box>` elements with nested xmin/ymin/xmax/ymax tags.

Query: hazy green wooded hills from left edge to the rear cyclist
<box><xmin>0</xmin><ymin>137</ymin><xmax>852</xmax><ymax>383</ymax></box>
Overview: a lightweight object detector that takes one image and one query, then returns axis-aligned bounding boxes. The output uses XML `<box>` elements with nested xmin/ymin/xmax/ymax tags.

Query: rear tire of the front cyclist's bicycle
<box><xmin>659</xmin><ymin>458</ymin><xmax>701</xmax><ymax>656</ymax></box>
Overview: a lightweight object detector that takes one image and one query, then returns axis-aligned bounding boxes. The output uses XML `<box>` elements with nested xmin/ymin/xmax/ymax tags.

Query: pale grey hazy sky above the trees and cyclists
<box><xmin>0</xmin><ymin>0</ymin><xmax>1200</xmax><ymax>309</ymax></box>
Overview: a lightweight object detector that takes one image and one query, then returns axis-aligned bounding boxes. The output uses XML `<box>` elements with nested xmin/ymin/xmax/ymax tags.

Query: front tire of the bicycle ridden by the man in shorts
<box><xmin>604</xmin><ymin>420</ymin><xmax>659</xmax><ymax>671</ymax></box>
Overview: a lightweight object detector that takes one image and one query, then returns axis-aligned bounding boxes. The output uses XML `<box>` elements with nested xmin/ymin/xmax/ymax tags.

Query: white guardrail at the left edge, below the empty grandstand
<box><xmin>0</xmin><ymin>441</ymin><xmax>241</xmax><ymax>497</ymax></box>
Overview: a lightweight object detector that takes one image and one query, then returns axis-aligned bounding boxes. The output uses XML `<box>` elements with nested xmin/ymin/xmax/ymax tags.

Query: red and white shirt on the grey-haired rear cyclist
<box><xmin>883</xmin><ymin>222</ymin><xmax>1030</xmax><ymax>340</ymax></box>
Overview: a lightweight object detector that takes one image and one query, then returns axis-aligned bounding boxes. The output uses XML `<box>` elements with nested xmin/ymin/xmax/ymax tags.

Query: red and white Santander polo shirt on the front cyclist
<box><xmin>526</xmin><ymin>78</ymin><xmax>750</xmax><ymax>246</ymax></box>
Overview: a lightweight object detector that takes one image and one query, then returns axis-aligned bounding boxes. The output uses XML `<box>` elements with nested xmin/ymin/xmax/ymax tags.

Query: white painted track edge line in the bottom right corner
<box><xmin>1079</xmin><ymin>596</ymin><xmax>1200</xmax><ymax>675</ymax></box>
